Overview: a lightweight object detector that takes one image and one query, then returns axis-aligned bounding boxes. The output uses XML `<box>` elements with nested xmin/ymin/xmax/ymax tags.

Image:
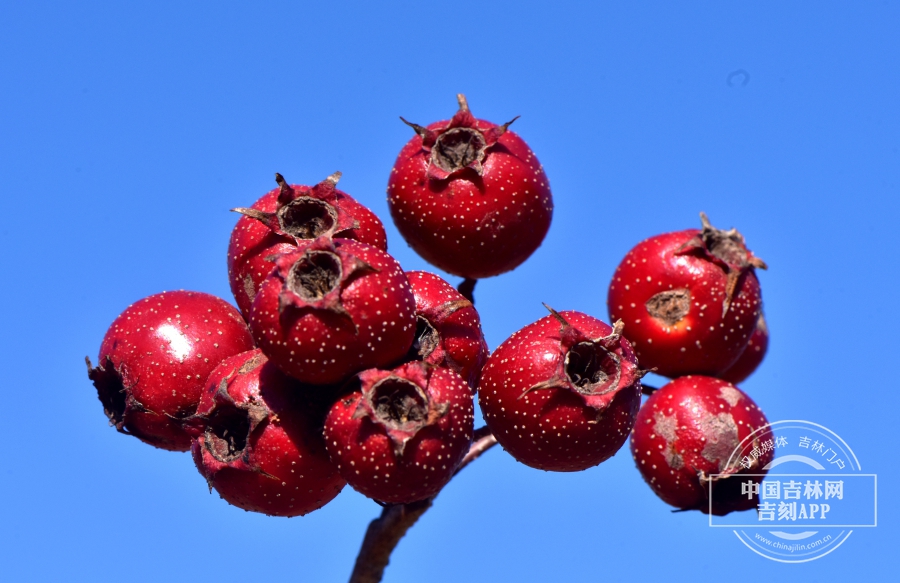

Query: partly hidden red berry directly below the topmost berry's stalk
<box><xmin>406</xmin><ymin>271</ymin><xmax>488</xmax><ymax>389</ymax></box>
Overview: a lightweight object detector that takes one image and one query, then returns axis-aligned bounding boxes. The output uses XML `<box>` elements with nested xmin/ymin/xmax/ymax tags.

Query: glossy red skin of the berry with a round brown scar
<box><xmin>607</xmin><ymin>229</ymin><xmax>762</xmax><ymax>377</ymax></box>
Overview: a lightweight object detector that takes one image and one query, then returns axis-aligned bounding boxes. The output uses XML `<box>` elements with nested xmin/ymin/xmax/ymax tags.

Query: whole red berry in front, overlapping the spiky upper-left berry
<box><xmin>250</xmin><ymin>237</ymin><xmax>416</xmax><ymax>385</ymax></box>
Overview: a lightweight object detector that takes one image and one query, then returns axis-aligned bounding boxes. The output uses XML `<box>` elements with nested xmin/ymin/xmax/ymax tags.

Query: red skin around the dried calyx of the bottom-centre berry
<box><xmin>325</xmin><ymin>362</ymin><xmax>475</xmax><ymax>504</ymax></box>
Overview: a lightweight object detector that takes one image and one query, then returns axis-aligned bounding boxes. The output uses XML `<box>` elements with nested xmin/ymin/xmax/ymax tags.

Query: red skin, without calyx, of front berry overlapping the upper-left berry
<box><xmin>250</xmin><ymin>239</ymin><xmax>416</xmax><ymax>385</ymax></box>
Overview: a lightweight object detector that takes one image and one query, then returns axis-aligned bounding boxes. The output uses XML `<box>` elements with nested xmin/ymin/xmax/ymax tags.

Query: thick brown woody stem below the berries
<box><xmin>350</xmin><ymin>427</ymin><xmax>497</xmax><ymax>583</ymax></box>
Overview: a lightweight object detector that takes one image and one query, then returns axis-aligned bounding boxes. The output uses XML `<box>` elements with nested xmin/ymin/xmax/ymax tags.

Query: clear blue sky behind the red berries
<box><xmin>0</xmin><ymin>0</ymin><xmax>900</xmax><ymax>582</ymax></box>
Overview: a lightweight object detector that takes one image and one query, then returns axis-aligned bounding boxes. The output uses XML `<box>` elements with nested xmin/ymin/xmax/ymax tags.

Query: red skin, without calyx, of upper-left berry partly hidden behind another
<box><xmin>228</xmin><ymin>184</ymin><xmax>387</xmax><ymax>319</ymax></box>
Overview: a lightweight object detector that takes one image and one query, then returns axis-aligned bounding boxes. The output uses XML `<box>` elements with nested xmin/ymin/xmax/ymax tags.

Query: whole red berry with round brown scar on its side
<box><xmin>607</xmin><ymin>213</ymin><xmax>765</xmax><ymax>377</ymax></box>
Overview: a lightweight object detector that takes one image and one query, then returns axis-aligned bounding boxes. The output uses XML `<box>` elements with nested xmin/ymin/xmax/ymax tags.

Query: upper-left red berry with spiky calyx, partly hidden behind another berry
<box><xmin>228</xmin><ymin>172</ymin><xmax>387</xmax><ymax>317</ymax></box>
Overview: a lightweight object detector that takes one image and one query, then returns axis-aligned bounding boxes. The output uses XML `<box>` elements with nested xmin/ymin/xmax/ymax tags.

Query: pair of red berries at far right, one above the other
<box><xmin>607</xmin><ymin>213</ymin><xmax>773</xmax><ymax>515</ymax></box>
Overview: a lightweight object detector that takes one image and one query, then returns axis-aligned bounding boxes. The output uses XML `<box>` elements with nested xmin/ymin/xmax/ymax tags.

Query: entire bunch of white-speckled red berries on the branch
<box><xmin>88</xmin><ymin>96</ymin><xmax>767</xmax><ymax>516</ymax></box>
